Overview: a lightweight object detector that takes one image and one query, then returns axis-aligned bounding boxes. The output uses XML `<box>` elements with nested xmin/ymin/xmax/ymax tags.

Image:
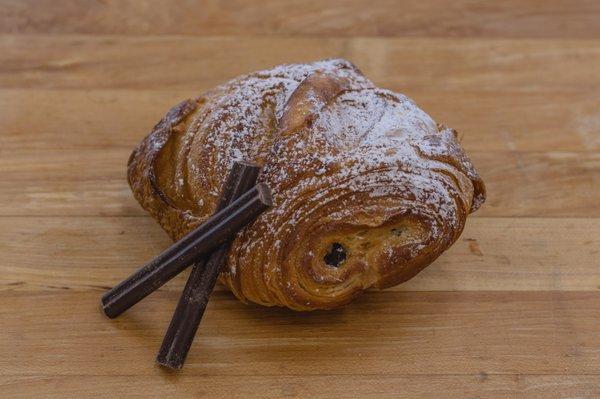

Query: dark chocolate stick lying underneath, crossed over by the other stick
<box><xmin>156</xmin><ymin>165</ymin><xmax>260</xmax><ymax>369</ymax></box>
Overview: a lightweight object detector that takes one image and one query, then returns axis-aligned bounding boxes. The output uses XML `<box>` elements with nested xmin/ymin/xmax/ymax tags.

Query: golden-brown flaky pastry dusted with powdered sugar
<box><xmin>128</xmin><ymin>60</ymin><xmax>485</xmax><ymax>310</ymax></box>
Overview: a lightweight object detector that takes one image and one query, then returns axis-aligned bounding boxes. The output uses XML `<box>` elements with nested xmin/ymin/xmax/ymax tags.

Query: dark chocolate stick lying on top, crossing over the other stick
<box><xmin>102</xmin><ymin>183</ymin><xmax>272</xmax><ymax>318</ymax></box>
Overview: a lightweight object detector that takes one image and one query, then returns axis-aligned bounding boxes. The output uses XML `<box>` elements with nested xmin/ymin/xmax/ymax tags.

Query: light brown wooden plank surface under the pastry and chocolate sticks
<box><xmin>0</xmin><ymin>0</ymin><xmax>600</xmax><ymax>398</ymax></box>
